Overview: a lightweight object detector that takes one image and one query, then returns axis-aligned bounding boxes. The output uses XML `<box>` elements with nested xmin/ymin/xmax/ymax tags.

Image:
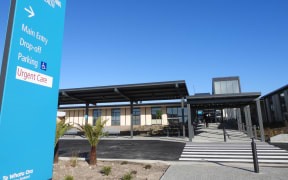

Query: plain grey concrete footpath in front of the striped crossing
<box><xmin>161</xmin><ymin>163</ymin><xmax>288</xmax><ymax>180</ymax></box>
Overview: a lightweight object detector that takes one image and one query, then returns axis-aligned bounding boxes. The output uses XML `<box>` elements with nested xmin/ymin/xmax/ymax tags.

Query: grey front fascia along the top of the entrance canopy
<box><xmin>186</xmin><ymin>92</ymin><xmax>261</xmax><ymax>101</ymax></box>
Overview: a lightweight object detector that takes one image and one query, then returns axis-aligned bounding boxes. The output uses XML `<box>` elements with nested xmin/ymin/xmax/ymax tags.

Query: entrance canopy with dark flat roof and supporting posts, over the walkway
<box><xmin>187</xmin><ymin>92</ymin><xmax>264</xmax><ymax>141</ymax></box>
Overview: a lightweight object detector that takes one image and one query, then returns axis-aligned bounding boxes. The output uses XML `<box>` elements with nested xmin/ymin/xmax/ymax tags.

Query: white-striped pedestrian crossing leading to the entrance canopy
<box><xmin>179</xmin><ymin>142</ymin><xmax>288</xmax><ymax>165</ymax></box>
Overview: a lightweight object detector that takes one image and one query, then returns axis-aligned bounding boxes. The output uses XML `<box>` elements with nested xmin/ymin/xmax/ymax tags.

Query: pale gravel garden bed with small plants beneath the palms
<box><xmin>53</xmin><ymin>160</ymin><xmax>168</xmax><ymax>180</ymax></box>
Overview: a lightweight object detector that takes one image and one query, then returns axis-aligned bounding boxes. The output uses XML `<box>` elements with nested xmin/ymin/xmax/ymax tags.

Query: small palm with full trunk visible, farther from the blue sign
<box><xmin>80</xmin><ymin>118</ymin><xmax>107</xmax><ymax>165</ymax></box>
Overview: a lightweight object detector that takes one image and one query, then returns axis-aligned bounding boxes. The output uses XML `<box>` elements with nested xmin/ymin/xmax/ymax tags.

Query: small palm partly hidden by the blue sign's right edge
<box><xmin>54</xmin><ymin>120</ymin><xmax>72</xmax><ymax>163</ymax></box>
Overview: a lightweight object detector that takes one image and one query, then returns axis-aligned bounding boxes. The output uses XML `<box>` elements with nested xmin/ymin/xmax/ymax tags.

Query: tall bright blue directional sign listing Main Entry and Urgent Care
<box><xmin>0</xmin><ymin>0</ymin><xmax>66</xmax><ymax>180</ymax></box>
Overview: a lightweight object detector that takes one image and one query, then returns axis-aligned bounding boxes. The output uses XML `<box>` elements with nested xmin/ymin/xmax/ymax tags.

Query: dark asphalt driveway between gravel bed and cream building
<box><xmin>59</xmin><ymin>140</ymin><xmax>185</xmax><ymax>161</ymax></box>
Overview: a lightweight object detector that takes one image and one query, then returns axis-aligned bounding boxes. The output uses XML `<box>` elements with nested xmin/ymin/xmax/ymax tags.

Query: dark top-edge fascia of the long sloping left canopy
<box><xmin>59</xmin><ymin>80</ymin><xmax>189</xmax><ymax>95</ymax></box>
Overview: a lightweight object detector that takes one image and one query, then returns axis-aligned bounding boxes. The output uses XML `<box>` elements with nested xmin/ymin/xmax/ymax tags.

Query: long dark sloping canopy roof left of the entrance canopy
<box><xmin>58</xmin><ymin>81</ymin><xmax>189</xmax><ymax>105</ymax></box>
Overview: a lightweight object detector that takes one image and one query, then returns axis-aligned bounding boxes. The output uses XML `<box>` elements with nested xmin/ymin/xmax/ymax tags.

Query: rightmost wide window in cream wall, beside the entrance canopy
<box><xmin>167</xmin><ymin>107</ymin><xmax>188</xmax><ymax>123</ymax></box>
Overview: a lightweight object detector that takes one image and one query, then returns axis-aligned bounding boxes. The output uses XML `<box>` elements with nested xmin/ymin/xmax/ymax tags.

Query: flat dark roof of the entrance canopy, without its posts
<box><xmin>187</xmin><ymin>92</ymin><xmax>261</xmax><ymax>109</ymax></box>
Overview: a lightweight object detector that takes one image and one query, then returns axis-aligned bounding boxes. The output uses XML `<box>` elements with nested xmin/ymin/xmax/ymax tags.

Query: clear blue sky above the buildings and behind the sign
<box><xmin>0</xmin><ymin>0</ymin><xmax>288</xmax><ymax>94</ymax></box>
